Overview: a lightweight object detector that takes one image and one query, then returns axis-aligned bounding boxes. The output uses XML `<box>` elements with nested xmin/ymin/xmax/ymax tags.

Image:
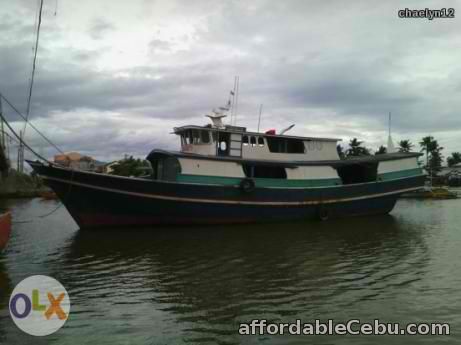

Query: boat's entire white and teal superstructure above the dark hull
<box><xmin>147</xmin><ymin>115</ymin><xmax>420</xmax><ymax>188</ymax></box>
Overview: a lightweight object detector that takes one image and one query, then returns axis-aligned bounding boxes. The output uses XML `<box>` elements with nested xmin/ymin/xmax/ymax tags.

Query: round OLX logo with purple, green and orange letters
<box><xmin>9</xmin><ymin>275</ymin><xmax>70</xmax><ymax>336</ymax></box>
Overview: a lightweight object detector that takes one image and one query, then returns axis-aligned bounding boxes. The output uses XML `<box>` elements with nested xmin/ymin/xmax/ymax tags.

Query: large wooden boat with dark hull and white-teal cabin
<box><xmin>28</xmin><ymin>112</ymin><xmax>425</xmax><ymax>228</ymax></box>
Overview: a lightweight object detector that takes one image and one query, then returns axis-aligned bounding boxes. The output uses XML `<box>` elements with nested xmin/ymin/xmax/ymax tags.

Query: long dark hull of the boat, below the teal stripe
<box><xmin>29</xmin><ymin>162</ymin><xmax>425</xmax><ymax>228</ymax></box>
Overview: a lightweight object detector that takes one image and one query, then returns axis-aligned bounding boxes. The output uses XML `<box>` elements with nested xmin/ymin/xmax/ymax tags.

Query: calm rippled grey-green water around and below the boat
<box><xmin>0</xmin><ymin>199</ymin><xmax>461</xmax><ymax>345</ymax></box>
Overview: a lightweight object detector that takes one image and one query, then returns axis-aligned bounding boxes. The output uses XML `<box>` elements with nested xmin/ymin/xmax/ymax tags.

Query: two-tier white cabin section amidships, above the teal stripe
<box><xmin>170</xmin><ymin>121</ymin><xmax>348</xmax><ymax>184</ymax></box>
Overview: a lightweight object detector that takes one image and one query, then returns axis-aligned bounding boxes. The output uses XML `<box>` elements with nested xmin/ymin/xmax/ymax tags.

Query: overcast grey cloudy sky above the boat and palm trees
<box><xmin>0</xmin><ymin>0</ymin><xmax>461</xmax><ymax>160</ymax></box>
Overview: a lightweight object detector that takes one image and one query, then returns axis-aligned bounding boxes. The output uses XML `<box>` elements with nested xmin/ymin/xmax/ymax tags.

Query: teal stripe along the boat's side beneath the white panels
<box><xmin>176</xmin><ymin>168</ymin><xmax>423</xmax><ymax>188</ymax></box>
